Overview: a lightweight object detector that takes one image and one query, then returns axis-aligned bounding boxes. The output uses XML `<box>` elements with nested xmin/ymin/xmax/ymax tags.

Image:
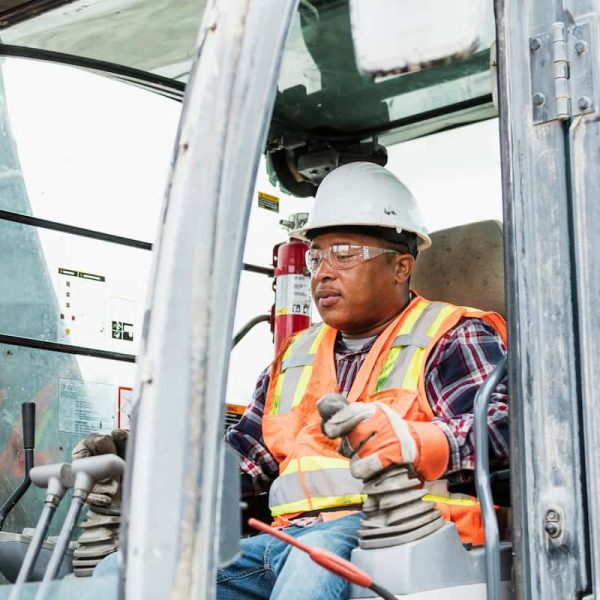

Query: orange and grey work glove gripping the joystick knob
<box><xmin>317</xmin><ymin>394</ymin><xmax>450</xmax><ymax>481</ymax></box>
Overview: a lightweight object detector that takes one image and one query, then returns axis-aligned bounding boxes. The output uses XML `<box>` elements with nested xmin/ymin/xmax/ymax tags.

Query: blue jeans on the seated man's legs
<box><xmin>217</xmin><ymin>513</ymin><xmax>363</xmax><ymax>600</ymax></box>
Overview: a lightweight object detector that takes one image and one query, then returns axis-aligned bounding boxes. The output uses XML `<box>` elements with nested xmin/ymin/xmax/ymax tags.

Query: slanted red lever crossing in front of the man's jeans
<box><xmin>248</xmin><ymin>519</ymin><xmax>396</xmax><ymax>600</ymax></box>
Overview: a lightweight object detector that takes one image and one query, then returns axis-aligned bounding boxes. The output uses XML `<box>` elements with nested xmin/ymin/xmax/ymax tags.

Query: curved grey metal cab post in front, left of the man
<box><xmin>125</xmin><ymin>0</ymin><xmax>296</xmax><ymax>600</ymax></box>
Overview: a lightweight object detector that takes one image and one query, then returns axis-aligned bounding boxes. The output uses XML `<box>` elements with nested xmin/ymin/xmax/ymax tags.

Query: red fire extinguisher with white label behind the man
<box><xmin>271</xmin><ymin>213</ymin><xmax>311</xmax><ymax>352</ymax></box>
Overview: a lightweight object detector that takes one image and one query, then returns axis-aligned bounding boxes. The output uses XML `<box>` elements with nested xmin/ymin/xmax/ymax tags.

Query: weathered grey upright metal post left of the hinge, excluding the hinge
<box><xmin>496</xmin><ymin>0</ymin><xmax>589</xmax><ymax>600</ymax></box>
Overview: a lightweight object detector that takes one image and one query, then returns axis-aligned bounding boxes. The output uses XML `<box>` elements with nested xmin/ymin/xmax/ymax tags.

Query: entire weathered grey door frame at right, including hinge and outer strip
<box><xmin>495</xmin><ymin>0</ymin><xmax>600</xmax><ymax>600</ymax></box>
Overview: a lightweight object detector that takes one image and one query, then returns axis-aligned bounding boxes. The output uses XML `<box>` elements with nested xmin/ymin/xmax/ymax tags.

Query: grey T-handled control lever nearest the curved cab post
<box><xmin>35</xmin><ymin>454</ymin><xmax>125</xmax><ymax>600</ymax></box>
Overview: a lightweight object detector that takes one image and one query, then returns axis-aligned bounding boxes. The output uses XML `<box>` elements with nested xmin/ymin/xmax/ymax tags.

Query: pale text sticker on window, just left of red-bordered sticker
<box><xmin>58</xmin><ymin>378</ymin><xmax>116</xmax><ymax>435</ymax></box>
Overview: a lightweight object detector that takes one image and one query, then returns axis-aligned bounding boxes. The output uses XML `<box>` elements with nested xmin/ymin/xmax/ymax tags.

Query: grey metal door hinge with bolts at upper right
<box><xmin>529</xmin><ymin>19</ymin><xmax>596</xmax><ymax>124</ymax></box>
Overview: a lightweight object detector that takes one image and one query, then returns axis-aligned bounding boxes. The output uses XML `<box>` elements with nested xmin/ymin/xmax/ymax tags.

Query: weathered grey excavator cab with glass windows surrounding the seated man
<box><xmin>0</xmin><ymin>0</ymin><xmax>600</xmax><ymax>600</ymax></box>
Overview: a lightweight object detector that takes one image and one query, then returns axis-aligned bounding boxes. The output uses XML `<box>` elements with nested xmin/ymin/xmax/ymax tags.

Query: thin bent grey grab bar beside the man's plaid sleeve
<box><xmin>473</xmin><ymin>358</ymin><xmax>506</xmax><ymax>600</ymax></box>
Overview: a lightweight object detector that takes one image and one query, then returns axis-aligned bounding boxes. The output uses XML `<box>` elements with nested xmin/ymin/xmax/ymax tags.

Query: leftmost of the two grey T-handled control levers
<box><xmin>9</xmin><ymin>463</ymin><xmax>73</xmax><ymax>600</ymax></box>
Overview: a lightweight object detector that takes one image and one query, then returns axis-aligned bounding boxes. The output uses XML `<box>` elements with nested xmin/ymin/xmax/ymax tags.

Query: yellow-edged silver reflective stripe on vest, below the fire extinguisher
<box><xmin>271</xmin><ymin>324</ymin><xmax>325</xmax><ymax>415</ymax></box>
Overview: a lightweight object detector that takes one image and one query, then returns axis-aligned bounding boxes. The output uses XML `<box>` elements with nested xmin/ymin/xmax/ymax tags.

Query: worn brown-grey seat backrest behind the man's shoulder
<box><xmin>411</xmin><ymin>221</ymin><xmax>506</xmax><ymax>317</ymax></box>
